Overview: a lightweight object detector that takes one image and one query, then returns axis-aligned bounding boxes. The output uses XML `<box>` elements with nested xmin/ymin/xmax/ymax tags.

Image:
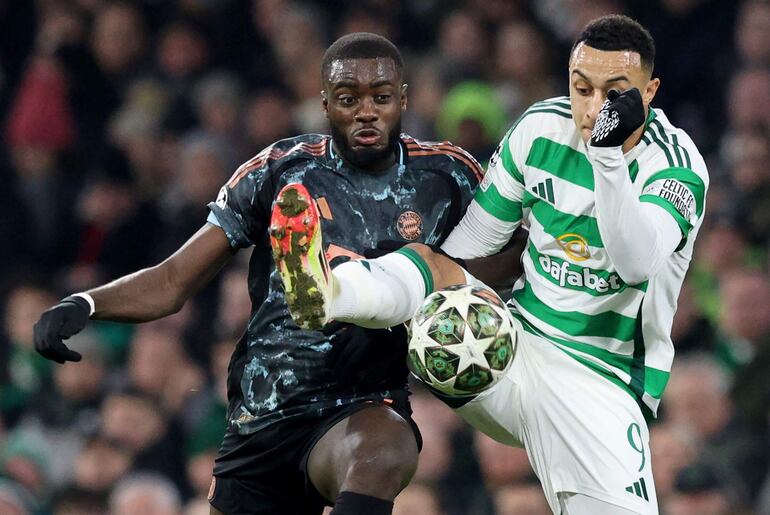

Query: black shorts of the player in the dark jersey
<box><xmin>209</xmin><ymin>390</ymin><xmax>422</xmax><ymax>515</ymax></box>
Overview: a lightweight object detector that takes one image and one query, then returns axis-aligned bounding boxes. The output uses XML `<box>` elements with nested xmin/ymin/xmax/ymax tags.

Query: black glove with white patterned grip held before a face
<box><xmin>591</xmin><ymin>88</ymin><xmax>644</xmax><ymax>147</ymax></box>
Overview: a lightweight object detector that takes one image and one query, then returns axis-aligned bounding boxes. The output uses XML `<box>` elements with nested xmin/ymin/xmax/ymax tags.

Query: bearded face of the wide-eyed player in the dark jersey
<box><xmin>323</xmin><ymin>58</ymin><xmax>406</xmax><ymax>170</ymax></box>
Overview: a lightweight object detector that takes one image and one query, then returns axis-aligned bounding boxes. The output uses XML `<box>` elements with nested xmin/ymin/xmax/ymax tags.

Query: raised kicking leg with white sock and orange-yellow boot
<box><xmin>270</xmin><ymin>184</ymin><xmax>469</xmax><ymax>329</ymax></box>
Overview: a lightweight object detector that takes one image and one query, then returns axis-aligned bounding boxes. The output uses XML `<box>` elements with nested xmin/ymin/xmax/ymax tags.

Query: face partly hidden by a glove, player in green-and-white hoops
<box><xmin>569</xmin><ymin>43</ymin><xmax>660</xmax><ymax>150</ymax></box>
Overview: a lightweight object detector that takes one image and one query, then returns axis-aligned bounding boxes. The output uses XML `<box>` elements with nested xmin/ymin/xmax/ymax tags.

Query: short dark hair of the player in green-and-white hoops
<box><xmin>572</xmin><ymin>14</ymin><xmax>655</xmax><ymax>73</ymax></box>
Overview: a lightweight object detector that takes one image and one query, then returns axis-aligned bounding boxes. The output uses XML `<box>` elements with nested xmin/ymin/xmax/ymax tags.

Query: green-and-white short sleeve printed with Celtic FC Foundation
<box><xmin>639</xmin><ymin>161</ymin><xmax>707</xmax><ymax>250</ymax></box>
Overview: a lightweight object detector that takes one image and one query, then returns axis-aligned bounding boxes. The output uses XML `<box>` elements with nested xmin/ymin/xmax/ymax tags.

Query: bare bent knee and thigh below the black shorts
<box><xmin>307</xmin><ymin>405</ymin><xmax>418</xmax><ymax>500</ymax></box>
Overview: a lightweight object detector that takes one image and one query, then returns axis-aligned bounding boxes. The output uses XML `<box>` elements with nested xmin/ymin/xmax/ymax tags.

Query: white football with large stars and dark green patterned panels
<box><xmin>407</xmin><ymin>284</ymin><xmax>516</xmax><ymax>397</ymax></box>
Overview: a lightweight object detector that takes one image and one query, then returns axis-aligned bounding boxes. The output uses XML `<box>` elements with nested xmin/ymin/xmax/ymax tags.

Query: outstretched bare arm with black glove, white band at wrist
<box><xmin>34</xmin><ymin>223</ymin><xmax>232</xmax><ymax>363</ymax></box>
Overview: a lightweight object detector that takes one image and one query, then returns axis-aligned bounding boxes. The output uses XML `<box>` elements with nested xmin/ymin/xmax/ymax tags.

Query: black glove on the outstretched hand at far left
<box><xmin>34</xmin><ymin>296</ymin><xmax>91</xmax><ymax>363</ymax></box>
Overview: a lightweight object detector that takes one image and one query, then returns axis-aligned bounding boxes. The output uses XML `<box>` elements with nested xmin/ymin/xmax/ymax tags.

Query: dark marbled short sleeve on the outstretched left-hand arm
<box><xmin>208</xmin><ymin>147</ymin><xmax>275</xmax><ymax>249</ymax></box>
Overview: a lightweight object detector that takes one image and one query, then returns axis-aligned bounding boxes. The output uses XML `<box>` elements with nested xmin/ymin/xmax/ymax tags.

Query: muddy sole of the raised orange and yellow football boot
<box><xmin>269</xmin><ymin>183</ymin><xmax>333</xmax><ymax>330</ymax></box>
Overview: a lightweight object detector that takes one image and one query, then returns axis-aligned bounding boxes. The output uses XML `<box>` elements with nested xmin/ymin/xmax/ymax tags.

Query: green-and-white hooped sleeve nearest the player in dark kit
<box><xmin>442</xmin><ymin>125</ymin><xmax>525</xmax><ymax>259</ymax></box>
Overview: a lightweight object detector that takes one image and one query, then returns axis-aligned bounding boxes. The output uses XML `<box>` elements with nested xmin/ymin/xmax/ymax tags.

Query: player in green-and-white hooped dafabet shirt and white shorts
<box><xmin>274</xmin><ymin>15</ymin><xmax>708</xmax><ymax>515</ymax></box>
